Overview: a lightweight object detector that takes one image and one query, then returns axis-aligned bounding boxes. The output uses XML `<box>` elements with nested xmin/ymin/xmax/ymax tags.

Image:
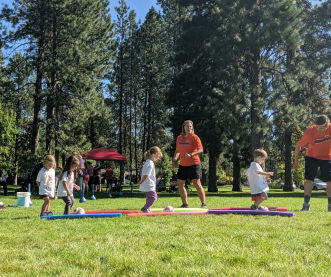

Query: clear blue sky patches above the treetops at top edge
<box><xmin>0</xmin><ymin>0</ymin><xmax>161</xmax><ymax>22</ymax></box>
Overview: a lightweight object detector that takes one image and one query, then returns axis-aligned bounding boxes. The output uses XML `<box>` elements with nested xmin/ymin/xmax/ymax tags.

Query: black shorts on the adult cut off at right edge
<box><xmin>305</xmin><ymin>156</ymin><xmax>331</xmax><ymax>182</ymax></box>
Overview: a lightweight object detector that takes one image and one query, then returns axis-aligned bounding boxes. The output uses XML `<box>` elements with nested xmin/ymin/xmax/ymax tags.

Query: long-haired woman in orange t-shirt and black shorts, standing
<box><xmin>172</xmin><ymin>120</ymin><xmax>207</xmax><ymax>208</ymax></box>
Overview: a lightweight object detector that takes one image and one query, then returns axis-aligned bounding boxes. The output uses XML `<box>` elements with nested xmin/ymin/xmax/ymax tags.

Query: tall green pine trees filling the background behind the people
<box><xmin>0</xmin><ymin>0</ymin><xmax>331</xmax><ymax>192</ymax></box>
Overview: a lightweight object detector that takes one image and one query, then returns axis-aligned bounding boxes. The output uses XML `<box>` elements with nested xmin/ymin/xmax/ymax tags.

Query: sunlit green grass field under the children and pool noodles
<box><xmin>0</xmin><ymin>183</ymin><xmax>331</xmax><ymax>276</ymax></box>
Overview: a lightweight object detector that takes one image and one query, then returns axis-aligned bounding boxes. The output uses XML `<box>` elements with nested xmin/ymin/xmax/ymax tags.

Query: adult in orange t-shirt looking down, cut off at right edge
<box><xmin>293</xmin><ymin>115</ymin><xmax>331</xmax><ymax>212</ymax></box>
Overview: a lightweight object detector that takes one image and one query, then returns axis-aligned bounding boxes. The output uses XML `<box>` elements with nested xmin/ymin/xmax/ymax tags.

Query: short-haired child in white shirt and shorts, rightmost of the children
<box><xmin>246</xmin><ymin>149</ymin><xmax>274</xmax><ymax>211</ymax></box>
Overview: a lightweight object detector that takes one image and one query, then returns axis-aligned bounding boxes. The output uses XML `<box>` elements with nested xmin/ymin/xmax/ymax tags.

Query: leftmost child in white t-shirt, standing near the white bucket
<box><xmin>36</xmin><ymin>155</ymin><xmax>56</xmax><ymax>216</ymax></box>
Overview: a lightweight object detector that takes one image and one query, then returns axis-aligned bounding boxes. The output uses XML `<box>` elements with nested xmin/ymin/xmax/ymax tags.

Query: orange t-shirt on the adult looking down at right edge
<box><xmin>299</xmin><ymin>124</ymin><xmax>331</xmax><ymax>160</ymax></box>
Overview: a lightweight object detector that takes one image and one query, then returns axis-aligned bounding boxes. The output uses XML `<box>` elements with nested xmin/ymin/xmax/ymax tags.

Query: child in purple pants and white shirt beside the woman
<box><xmin>138</xmin><ymin>146</ymin><xmax>162</xmax><ymax>213</ymax></box>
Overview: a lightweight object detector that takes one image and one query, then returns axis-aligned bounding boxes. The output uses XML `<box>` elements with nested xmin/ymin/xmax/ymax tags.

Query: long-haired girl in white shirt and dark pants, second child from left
<box><xmin>57</xmin><ymin>156</ymin><xmax>80</xmax><ymax>214</ymax></box>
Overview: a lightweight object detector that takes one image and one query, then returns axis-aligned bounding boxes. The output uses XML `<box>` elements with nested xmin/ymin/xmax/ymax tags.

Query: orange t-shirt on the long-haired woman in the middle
<box><xmin>176</xmin><ymin>134</ymin><xmax>202</xmax><ymax>166</ymax></box>
